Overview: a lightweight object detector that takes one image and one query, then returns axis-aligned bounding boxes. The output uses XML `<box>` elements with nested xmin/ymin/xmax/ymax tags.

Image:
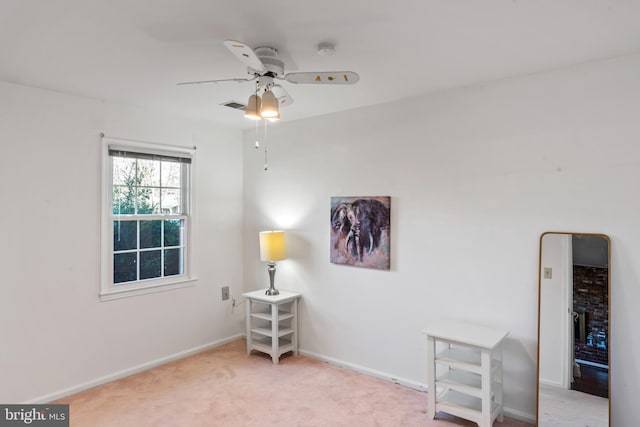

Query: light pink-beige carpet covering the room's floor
<box><xmin>55</xmin><ymin>340</ymin><xmax>528</xmax><ymax>427</ymax></box>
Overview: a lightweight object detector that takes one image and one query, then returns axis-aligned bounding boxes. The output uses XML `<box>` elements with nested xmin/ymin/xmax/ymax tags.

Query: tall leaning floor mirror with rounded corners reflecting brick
<box><xmin>537</xmin><ymin>232</ymin><xmax>611</xmax><ymax>427</ymax></box>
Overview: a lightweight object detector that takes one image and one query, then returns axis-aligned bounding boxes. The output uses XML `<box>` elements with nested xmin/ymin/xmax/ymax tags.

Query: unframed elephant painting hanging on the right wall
<box><xmin>329</xmin><ymin>196</ymin><xmax>391</xmax><ymax>270</ymax></box>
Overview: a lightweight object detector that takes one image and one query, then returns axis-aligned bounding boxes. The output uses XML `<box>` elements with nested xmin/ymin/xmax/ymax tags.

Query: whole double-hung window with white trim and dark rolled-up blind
<box><xmin>100</xmin><ymin>138</ymin><xmax>194</xmax><ymax>300</ymax></box>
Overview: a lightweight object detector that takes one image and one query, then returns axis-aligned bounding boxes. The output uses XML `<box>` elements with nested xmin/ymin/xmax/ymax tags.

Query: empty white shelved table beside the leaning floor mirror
<box><xmin>422</xmin><ymin>322</ymin><xmax>509</xmax><ymax>427</ymax></box>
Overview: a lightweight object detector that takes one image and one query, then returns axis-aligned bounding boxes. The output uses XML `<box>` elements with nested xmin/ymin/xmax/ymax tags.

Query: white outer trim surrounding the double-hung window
<box><xmin>100</xmin><ymin>137</ymin><xmax>198</xmax><ymax>301</ymax></box>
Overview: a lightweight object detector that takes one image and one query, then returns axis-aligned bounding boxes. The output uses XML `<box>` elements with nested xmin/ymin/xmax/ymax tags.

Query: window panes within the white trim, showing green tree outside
<box><xmin>110</xmin><ymin>151</ymin><xmax>188</xmax><ymax>285</ymax></box>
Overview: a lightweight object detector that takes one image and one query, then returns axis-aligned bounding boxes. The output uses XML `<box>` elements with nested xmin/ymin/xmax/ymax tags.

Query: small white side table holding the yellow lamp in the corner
<box><xmin>242</xmin><ymin>289</ymin><xmax>301</xmax><ymax>364</ymax></box>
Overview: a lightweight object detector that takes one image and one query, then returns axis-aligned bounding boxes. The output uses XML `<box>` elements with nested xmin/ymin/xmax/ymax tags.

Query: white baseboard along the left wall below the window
<box><xmin>23</xmin><ymin>334</ymin><xmax>243</xmax><ymax>405</ymax></box>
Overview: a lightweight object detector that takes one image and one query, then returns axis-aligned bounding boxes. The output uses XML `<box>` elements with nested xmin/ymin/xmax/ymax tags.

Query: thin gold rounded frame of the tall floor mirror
<box><xmin>536</xmin><ymin>231</ymin><xmax>611</xmax><ymax>427</ymax></box>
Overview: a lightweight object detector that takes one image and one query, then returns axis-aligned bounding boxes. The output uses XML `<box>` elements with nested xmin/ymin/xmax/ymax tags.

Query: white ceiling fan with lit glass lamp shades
<box><xmin>178</xmin><ymin>40</ymin><xmax>360</xmax><ymax>120</ymax></box>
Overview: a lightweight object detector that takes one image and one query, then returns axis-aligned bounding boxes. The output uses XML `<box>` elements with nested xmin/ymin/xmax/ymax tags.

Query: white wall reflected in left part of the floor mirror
<box><xmin>539</xmin><ymin>234</ymin><xmax>573</xmax><ymax>389</ymax></box>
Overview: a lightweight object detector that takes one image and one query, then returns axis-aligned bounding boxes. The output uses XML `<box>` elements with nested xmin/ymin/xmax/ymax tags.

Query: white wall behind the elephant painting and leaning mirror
<box><xmin>244</xmin><ymin>56</ymin><xmax>640</xmax><ymax>426</ymax></box>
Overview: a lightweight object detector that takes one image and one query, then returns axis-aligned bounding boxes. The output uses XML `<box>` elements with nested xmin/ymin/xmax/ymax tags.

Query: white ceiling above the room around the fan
<box><xmin>0</xmin><ymin>0</ymin><xmax>640</xmax><ymax>129</ymax></box>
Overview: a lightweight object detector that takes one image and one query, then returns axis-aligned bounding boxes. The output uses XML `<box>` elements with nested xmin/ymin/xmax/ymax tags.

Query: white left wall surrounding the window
<box><xmin>0</xmin><ymin>83</ymin><xmax>243</xmax><ymax>403</ymax></box>
